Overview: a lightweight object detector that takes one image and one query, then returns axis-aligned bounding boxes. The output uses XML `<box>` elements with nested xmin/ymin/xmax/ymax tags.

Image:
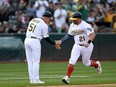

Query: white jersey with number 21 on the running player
<box><xmin>68</xmin><ymin>21</ymin><xmax>94</xmax><ymax>44</ymax></box>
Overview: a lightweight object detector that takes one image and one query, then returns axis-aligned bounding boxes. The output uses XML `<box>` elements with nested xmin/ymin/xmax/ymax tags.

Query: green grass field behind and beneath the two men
<box><xmin>0</xmin><ymin>61</ymin><xmax>116</xmax><ymax>87</ymax></box>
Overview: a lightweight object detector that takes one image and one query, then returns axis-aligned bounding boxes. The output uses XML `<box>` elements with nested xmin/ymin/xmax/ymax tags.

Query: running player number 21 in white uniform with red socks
<box><xmin>56</xmin><ymin>12</ymin><xmax>102</xmax><ymax>84</ymax></box>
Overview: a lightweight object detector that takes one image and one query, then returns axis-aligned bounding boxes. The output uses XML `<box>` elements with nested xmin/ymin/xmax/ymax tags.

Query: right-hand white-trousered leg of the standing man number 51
<box><xmin>32</xmin><ymin>39</ymin><xmax>44</xmax><ymax>83</ymax></box>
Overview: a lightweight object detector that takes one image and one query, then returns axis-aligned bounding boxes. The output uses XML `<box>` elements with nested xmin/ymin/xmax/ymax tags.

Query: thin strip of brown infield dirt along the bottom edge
<box><xmin>34</xmin><ymin>84</ymin><xmax>116</xmax><ymax>87</ymax></box>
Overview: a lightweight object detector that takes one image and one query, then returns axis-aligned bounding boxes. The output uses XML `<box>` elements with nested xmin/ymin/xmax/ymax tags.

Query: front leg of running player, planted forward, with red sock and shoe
<box><xmin>62</xmin><ymin>44</ymin><xmax>80</xmax><ymax>84</ymax></box>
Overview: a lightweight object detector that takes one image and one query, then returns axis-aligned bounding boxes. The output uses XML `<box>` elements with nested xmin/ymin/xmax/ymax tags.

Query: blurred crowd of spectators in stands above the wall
<box><xmin>0</xmin><ymin>0</ymin><xmax>116</xmax><ymax>34</ymax></box>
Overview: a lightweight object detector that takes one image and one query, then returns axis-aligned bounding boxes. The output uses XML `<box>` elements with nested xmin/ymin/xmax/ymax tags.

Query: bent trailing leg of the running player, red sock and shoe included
<box><xmin>82</xmin><ymin>43</ymin><xmax>102</xmax><ymax>73</ymax></box>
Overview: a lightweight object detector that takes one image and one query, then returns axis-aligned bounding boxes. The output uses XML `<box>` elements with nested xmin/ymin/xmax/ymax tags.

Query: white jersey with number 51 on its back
<box><xmin>26</xmin><ymin>18</ymin><xmax>49</xmax><ymax>40</ymax></box>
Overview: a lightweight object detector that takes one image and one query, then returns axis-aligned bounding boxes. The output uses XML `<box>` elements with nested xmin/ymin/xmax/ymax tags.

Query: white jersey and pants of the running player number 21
<box><xmin>68</xmin><ymin>21</ymin><xmax>94</xmax><ymax>66</ymax></box>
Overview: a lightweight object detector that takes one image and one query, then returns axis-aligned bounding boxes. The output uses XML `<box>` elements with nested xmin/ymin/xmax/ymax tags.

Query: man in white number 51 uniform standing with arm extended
<box><xmin>24</xmin><ymin>11</ymin><xmax>59</xmax><ymax>83</ymax></box>
